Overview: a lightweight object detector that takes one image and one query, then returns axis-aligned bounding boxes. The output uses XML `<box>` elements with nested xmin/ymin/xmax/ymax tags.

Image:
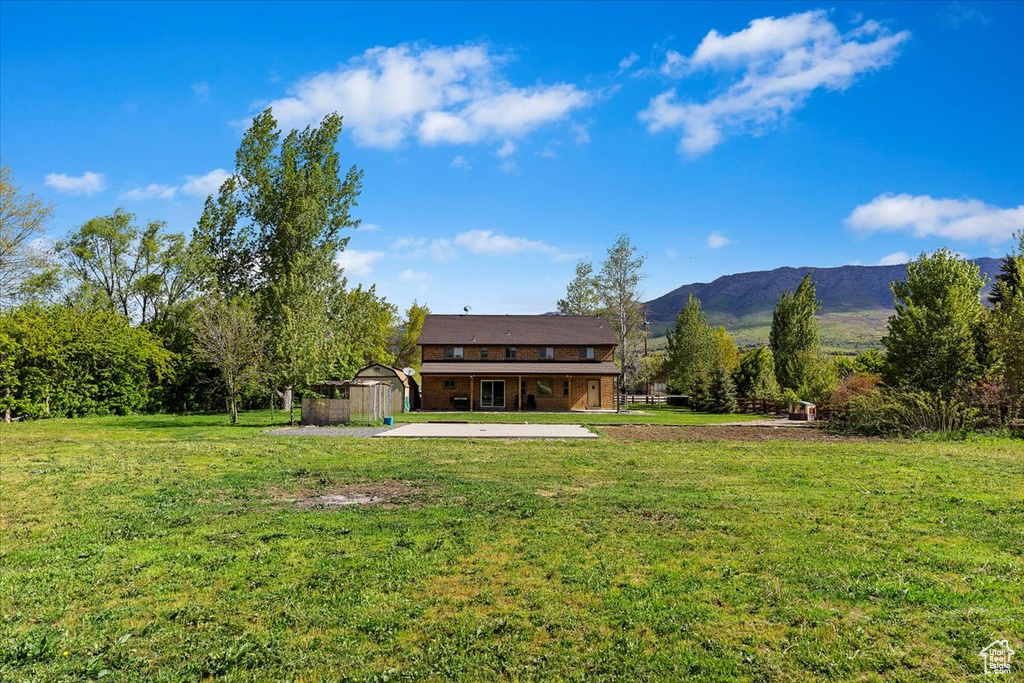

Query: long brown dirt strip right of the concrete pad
<box><xmin>600</xmin><ymin>425</ymin><xmax>869</xmax><ymax>441</ymax></box>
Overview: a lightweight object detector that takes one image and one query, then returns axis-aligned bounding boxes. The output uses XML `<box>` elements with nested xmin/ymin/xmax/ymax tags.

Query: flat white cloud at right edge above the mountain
<box><xmin>846</xmin><ymin>194</ymin><xmax>1024</xmax><ymax>244</ymax></box>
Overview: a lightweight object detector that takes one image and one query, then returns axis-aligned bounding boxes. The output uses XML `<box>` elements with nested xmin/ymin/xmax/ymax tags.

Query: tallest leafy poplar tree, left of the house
<box><xmin>195</xmin><ymin>110</ymin><xmax>362</xmax><ymax>412</ymax></box>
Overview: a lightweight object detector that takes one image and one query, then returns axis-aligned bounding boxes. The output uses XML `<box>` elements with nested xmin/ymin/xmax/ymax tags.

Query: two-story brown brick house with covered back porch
<box><xmin>419</xmin><ymin>315</ymin><xmax>618</xmax><ymax>411</ymax></box>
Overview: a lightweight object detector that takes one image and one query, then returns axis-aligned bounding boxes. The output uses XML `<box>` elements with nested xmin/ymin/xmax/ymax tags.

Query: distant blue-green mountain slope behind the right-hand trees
<box><xmin>647</xmin><ymin>258</ymin><xmax>999</xmax><ymax>350</ymax></box>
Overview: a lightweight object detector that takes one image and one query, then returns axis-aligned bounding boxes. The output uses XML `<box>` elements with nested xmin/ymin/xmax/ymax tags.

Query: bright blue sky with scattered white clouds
<box><xmin>0</xmin><ymin>2</ymin><xmax>1024</xmax><ymax>313</ymax></box>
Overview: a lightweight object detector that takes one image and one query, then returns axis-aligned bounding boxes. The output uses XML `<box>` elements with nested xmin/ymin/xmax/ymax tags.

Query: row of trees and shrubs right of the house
<box><xmin>662</xmin><ymin>237</ymin><xmax>1024</xmax><ymax>423</ymax></box>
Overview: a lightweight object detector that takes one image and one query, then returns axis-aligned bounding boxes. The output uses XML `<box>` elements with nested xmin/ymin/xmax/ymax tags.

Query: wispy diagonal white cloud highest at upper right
<box><xmin>639</xmin><ymin>10</ymin><xmax>910</xmax><ymax>157</ymax></box>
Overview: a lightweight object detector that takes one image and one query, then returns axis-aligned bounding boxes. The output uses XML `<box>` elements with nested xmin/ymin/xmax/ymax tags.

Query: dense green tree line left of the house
<box><xmin>0</xmin><ymin>110</ymin><xmax>429</xmax><ymax>422</ymax></box>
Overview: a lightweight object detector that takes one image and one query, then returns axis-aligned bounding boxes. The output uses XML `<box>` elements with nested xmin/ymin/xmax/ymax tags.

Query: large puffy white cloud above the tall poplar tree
<box><xmin>260</xmin><ymin>44</ymin><xmax>594</xmax><ymax>148</ymax></box>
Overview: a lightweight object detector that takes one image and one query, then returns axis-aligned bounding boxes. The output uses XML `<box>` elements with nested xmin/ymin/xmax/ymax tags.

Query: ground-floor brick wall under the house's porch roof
<box><xmin>421</xmin><ymin>375</ymin><xmax>614</xmax><ymax>412</ymax></box>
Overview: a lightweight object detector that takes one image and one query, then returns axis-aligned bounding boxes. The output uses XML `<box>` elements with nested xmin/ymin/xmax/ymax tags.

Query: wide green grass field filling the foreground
<box><xmin>0</xmin><ymin>415</ymin><xmax>1024</xmax><ymax>681</ymax></box>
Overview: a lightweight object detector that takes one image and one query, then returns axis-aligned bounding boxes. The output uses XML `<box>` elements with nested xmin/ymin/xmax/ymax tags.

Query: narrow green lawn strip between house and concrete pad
<box><xmin>394</xmin><ymin>403</ymin><xmax>765</xmax><ymax>425</ymax></box>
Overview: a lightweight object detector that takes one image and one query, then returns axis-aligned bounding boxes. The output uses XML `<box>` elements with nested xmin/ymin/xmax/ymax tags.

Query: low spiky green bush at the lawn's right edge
<box><xmin>829</xmin><ymin>390</ymin><xmax>982</xmax><ymax>436</ymax></box>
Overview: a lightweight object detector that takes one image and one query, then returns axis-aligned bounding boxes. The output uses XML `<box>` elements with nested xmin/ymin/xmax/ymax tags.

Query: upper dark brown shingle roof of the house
<box><xmin>419</xmin><ymin>315</ymin><xmax>615</xmax><ymax>346</ymax></box>
